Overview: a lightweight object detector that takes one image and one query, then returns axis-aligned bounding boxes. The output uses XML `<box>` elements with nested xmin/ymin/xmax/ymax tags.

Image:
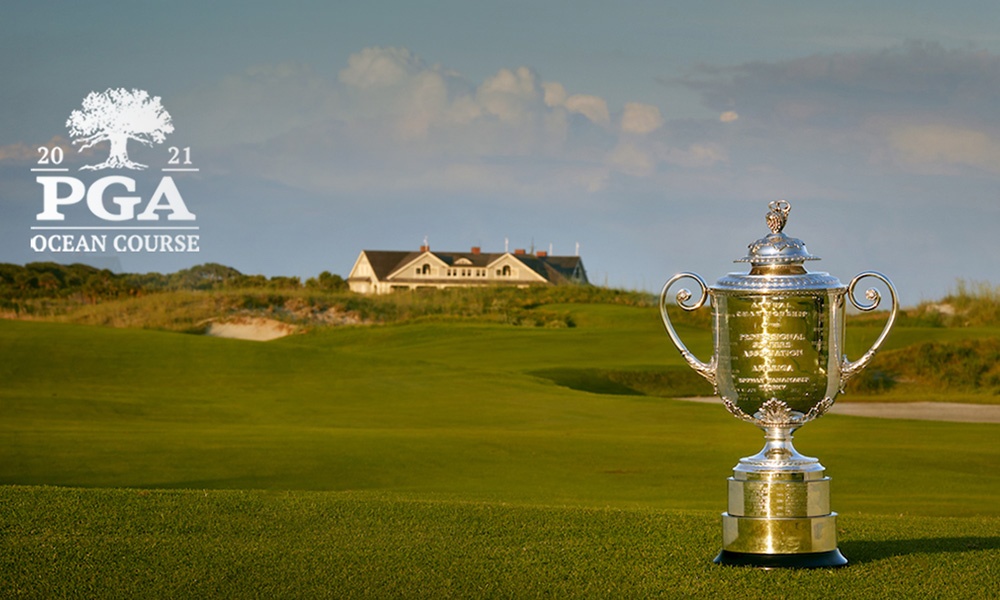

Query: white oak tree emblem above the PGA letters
<box><xmin>66</xmin><ymin>88</ymin><xmax>174</xmax><ymax>171</ymax></box>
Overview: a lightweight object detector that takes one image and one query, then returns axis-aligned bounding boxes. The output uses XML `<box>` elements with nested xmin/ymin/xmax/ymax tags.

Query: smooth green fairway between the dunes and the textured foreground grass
<box><xmin>0</xmin><ymin>305</ymin><xmax>1000</xmax><ymax>516</ymax></box>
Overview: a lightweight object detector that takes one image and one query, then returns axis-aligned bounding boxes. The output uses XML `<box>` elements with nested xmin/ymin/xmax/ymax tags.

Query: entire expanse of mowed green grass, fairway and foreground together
<box><xmin>0</xmin><ymin>305</ymin><xmax>1000</xmax><ymax>598</ymax></box>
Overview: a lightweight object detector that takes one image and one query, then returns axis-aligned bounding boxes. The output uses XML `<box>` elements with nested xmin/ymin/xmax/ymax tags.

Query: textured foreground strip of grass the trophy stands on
<box><xmin>0</xmin><ymin>487</ymin><xmax>1000</xmax><ymax>600</ymax></box>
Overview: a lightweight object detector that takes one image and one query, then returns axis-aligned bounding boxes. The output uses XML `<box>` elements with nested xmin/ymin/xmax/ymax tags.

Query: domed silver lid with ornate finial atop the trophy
<box><xmin>712</xmin><ymin>200</ymin><xmax>844</xmax><ymax>293</ymax></box>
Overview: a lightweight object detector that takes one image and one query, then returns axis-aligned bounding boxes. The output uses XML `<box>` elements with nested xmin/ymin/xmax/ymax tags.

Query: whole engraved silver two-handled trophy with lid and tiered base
<box><xmin>660</xmin><ymin>200</ymin><xmax>899</xmax><ymax>568</ymax></box>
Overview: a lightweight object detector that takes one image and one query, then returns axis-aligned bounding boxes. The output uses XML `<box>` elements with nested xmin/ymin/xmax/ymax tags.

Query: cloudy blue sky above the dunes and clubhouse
<box><xmin>0</xmin><ymin>0</ymin><xmax>1000</xmax><ymax>304</ymax></box>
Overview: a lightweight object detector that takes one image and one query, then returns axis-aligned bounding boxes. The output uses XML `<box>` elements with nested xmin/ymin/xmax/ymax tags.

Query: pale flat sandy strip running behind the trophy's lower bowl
<box><xmin>677</xmin><ymin>398</ymin><xmax>1000</xmax><ymax>423</ymax></box>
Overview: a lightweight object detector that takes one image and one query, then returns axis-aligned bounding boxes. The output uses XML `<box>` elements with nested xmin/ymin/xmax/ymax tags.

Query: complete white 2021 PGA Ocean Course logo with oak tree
<box><xmin>28</xmin><ymin>88</ymin><xmax>201</xmax><ymax>253</ymax></box>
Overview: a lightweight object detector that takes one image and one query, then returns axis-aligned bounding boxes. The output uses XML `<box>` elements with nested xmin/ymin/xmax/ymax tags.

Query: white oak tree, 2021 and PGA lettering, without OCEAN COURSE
<box><xmin>36</xmin><ymin>88</ymin><xmax>197</xmax><ymax>222</ymax></box>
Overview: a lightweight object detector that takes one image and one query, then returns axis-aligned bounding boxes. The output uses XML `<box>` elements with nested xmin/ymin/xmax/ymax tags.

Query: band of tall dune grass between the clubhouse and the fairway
<box><xmin>7</xmin><ymin>286</ymin><xmax>652</xmax><ymax>333</ymax></box>
